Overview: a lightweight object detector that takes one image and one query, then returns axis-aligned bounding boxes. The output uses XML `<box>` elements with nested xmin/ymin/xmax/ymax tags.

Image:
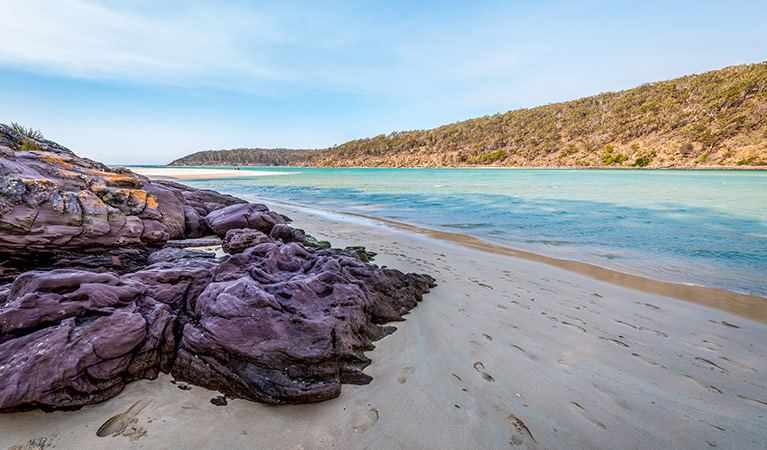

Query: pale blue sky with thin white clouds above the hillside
<box><xmin>0</xmin><ymin>0</ymin><xmax>767</xmax><ymax>164</ymax></box>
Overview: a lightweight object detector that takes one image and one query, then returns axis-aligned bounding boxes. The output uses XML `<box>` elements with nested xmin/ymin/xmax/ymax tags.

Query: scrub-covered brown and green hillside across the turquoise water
<box><xmin>173</xmin><ymin>62</ymin><xmax>767</xmax><ymax>167</ymax></box>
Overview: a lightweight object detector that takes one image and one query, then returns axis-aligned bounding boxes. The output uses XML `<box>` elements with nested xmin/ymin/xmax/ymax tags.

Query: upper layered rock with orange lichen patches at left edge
<box><xmin>0</xmin><ymin>126</ymin><xmax>245</xmax><ymax>279</ymax></box>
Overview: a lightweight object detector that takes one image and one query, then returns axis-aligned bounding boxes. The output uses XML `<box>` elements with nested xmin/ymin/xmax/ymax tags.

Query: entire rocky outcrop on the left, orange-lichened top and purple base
<box><xmin>0</xmin><ymin>127</ymin><xmax>434</xmax><ymax>411</ymax></box>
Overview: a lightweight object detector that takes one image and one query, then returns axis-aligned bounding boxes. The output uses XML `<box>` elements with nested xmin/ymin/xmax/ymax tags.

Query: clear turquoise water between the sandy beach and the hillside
<box><xmin>166</xmin><ymin>167</ymin><xmax>767</xmax><ymax>297</ymax></box>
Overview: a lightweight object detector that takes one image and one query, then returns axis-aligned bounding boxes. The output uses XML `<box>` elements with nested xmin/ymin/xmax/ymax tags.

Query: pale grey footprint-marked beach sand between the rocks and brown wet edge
<box><xmin>0</xmin><ymin>202</ymin><xmax>767</xmax><ymax>449</ymax></box>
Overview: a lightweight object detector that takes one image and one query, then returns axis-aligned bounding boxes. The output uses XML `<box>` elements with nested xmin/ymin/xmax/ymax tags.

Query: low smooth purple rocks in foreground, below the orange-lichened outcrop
<box><xmin>0</xmin><ymin>242</ymin><xmax>433</xmax><ymax>410</ymax></box>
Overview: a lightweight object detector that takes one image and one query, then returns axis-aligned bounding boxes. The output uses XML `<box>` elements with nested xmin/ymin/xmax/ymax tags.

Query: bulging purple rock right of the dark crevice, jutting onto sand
<box><xmin>172</xmin><ymin>243</ymin><xmax>433</xmax><ymax>403</ymax></box>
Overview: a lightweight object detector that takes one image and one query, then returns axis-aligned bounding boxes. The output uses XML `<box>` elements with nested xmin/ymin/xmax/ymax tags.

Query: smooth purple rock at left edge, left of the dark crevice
<box><xmin>0</xmin><ymin>269</ymin><xmax>175</xmax><ymax>410</ymax></box>
